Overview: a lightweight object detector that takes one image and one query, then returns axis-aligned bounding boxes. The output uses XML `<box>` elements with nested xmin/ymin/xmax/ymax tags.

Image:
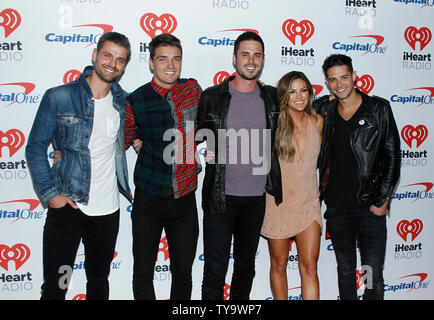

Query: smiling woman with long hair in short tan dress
<box><xmin>261</xmin><ymin>71</ymin><xmax>323</xmax><ymax>300</ymax></box>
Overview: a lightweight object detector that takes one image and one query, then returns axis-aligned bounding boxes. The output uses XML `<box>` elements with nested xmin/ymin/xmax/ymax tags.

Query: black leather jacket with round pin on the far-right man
<box><xmin>313</xmin><ymin>89</ymin><xmax>401</xmax><ymax>207</ymax></box>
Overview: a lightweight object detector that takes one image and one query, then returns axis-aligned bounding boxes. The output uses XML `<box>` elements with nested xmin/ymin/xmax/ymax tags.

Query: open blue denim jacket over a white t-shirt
<box><xmin>26</xmin><ymin>66</ymin><xmax>132</xmax><ymax>204</ymax></box>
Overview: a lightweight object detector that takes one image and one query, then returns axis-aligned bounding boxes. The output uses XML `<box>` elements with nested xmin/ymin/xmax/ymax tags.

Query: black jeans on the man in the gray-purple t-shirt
<box><xmin>202</xmin><ymin>196</ymin><xmax>265</xmax><ymax>300</ymax></box>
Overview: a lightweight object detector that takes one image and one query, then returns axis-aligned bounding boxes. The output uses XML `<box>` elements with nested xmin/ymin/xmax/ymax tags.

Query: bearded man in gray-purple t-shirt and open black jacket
<box><xmin>196</xmin><ymin>32</ymin><xmax>282</xmax><ymax>300</ymax></box>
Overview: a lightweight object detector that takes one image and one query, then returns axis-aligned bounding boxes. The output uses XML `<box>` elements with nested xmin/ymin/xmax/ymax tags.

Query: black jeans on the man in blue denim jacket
<box><xmin>41</xmin><ymin>204</ymin><xmax>119</xmax><ymax>300</ymax></box>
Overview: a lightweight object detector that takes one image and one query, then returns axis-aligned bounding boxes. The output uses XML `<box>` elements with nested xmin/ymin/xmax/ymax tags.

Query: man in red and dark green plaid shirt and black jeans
<box><xmin>125</xmin><ymin>34</ymin><xmax>201</xmax><ymax>300</ymax></box>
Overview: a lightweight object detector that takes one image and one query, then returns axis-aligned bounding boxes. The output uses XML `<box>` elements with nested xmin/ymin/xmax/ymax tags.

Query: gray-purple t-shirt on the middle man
<box><xmin>225</xmin><ymin>84</ymin><xmax>267</xmax><ymax>196</ymax></box>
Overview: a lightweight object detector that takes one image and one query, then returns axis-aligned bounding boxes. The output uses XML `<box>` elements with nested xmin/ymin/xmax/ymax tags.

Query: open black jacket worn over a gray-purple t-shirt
<box><xmin>197</xmin><ymin>76</ymin><xmax>282</xmax><ymax>213</ymax></box>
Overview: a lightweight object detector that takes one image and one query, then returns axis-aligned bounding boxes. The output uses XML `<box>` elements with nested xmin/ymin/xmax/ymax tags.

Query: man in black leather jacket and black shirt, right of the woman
<box><xmin>314</xmin><ymin>54</ymin><xmax>401</xmax><ymax>300</ymax></box>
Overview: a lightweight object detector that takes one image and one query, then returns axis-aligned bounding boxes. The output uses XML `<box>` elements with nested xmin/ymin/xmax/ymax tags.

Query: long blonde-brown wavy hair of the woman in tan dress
<box><xmin>275</xmin><ymin>71</ymin><xmax>316</xmax><ymax>161</ymax></box>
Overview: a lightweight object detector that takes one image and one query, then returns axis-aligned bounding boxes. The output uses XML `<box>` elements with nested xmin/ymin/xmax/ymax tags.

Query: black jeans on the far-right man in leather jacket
<box><xmin>325</xmin><ymin>208</ymin><xmax>387</xmax><ymax>300</ymax></box>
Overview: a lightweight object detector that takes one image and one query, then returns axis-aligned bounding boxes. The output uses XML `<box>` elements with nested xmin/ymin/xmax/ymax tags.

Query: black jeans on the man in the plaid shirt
<box><xmin>131</xmin><ymin>188</ymin><xmax>199</xmax><ymax>300</ymax></box>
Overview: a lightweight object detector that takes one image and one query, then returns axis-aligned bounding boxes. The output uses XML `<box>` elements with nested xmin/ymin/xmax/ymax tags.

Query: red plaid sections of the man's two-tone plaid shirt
<box><xmin>125</xmin><ymin>79</ymin><xmax>201</xmax><ymax>198</ymax></box>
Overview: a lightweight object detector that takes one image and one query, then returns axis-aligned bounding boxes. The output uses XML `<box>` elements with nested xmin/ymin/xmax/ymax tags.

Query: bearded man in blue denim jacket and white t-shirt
<box><xmin>26</xmin><ymin>32</ymin><xmax>132</xmax><ymax>300</ymax></box>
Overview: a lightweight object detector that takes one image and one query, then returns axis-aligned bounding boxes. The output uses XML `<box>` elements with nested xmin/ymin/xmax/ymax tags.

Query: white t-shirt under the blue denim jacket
<box><xmin>77</xmin><ymin>91</ymin><xmax>120</xmax><ymax>216</ymax></box>
